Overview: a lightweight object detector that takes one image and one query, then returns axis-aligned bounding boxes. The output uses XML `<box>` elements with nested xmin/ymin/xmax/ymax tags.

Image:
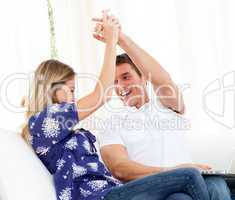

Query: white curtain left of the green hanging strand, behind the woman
<box><xmin>0</xmin><ymin>0</ymin><xmax>50</xmax><ymax>130</ymax></box>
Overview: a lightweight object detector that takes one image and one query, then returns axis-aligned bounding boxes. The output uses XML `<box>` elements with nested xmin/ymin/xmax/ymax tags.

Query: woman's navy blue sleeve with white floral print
<box><xmin>29</xmin><ymin>103</ymin><xmax>79</xmax><ymax>146</ymax></box>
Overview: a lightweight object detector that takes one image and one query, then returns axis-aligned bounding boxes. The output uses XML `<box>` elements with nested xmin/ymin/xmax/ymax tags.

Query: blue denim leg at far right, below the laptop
<box><xmin>204</xmin><ymin>176</ymin><xmax>231</xmax><ymax>200</ymax></box>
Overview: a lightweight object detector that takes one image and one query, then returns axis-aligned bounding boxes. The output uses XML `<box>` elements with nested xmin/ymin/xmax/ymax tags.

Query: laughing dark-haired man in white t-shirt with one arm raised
<box><xmin>95</xmin><ymin>16</ymin><xmax>231</xmax><ymax>200</ymax></box>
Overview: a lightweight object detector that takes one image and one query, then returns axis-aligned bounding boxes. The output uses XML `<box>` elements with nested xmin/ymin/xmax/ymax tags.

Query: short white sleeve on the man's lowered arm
<box><xmin>98</xmin><ymin>117</ymin><xmax>125</xmax><ymax>148</ymax></box>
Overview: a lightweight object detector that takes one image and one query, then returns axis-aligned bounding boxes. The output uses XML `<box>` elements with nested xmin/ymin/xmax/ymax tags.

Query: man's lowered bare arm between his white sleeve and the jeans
<box><xmin>100</xmin><ymin>144</ymin><xmax>163</xmax><ymax>182</ymax></box>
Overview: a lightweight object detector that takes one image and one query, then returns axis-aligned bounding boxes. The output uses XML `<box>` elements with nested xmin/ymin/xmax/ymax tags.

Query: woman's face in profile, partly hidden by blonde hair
<box><xmin>55</xmin><ymin>78</ymin><xmax>75</xmax><ymax>103</ymax></box>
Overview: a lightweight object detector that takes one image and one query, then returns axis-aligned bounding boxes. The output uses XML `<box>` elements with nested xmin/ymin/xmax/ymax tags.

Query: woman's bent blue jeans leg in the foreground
<box><xmin>105</xmin><ymin>168</ymin><xmax>209</xmax><ymax>200</ymax></box>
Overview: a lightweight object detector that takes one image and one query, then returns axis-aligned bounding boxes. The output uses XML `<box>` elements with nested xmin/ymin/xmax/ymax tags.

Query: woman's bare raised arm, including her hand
<box><xmin>77</xmin><ymin>11</ymin><xmax>119</xmax><ymax>120</ymax></box>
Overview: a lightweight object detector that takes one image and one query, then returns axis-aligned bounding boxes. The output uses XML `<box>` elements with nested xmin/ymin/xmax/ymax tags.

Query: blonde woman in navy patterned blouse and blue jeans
<box><xmin>23</xmin><ymin>11</ymin><xmax>209</xmax><ymax>200</ymax></box>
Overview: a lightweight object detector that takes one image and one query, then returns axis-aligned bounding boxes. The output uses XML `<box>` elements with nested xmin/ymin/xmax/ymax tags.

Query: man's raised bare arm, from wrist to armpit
<box><xmin>119</xmin><ymin>33</ymin><xmax>185</xmax><ymax>114</ymax></box>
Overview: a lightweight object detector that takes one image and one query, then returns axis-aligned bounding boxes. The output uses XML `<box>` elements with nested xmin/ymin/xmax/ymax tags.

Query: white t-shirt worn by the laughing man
<box><xmin>98</xmin><ymin>92</ymin><xmax>192</xmax><ymax>167</ymax></box>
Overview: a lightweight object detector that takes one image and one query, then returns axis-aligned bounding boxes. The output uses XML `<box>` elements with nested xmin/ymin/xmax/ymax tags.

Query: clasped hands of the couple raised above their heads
<box><xmin>93</xmin><ymin>10</ymin><xmax>121</xmax><ymax>44</ymax></box>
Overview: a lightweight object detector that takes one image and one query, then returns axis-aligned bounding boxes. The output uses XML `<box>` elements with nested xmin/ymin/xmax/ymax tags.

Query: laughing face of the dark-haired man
<box><xmin>115</xmin><ymin>63</ymin><xmax>146</xmax><ymax>107</ymax></box>
